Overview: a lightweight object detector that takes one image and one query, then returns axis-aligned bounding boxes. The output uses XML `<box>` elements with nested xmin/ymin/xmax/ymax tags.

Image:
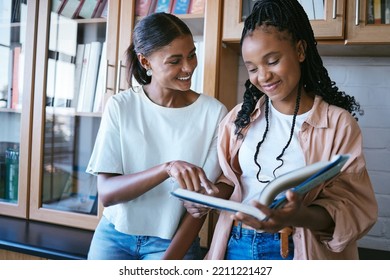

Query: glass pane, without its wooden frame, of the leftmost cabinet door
<box><xmin>0</xmin><ymin>0</ymin><xmax>27</xmax><ymax>204</ymax></box>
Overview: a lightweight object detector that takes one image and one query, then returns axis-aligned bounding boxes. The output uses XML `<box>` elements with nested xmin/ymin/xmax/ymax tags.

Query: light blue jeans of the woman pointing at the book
<box><xmin>88</xmin><ymin>216</ymin><xmax>201</xmax><ymax>260</ymax></box>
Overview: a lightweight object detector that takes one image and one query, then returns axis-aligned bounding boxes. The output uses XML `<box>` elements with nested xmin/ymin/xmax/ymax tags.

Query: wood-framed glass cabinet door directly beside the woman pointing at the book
<box><xmin>30</xmin><ymin>0</ymin><xmax>109</xmax><ymax>229</ymax></box>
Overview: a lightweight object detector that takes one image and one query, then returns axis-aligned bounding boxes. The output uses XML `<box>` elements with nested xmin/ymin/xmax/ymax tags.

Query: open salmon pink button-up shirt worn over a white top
<box><xmin>205</xmin><ymin>96</ymin><xmax>378</xmax><ymax>260</ymax></box>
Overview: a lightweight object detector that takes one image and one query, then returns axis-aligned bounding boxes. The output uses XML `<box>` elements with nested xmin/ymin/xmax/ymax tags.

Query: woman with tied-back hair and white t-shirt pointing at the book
<box><xmin>87</xmin><ymin>13</ymin><xmax>227</xmax><ymax>260</ymax></box>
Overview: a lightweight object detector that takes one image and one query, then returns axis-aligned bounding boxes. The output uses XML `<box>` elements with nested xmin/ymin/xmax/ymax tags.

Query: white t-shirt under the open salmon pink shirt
<box><xmin>238</xmin><ymin>101</ymin><xmax>310</xmax><ymax>204</ymax></box>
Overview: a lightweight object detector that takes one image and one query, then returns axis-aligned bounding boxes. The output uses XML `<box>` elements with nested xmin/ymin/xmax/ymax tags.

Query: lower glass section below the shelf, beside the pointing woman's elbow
<box><xmin>42</xmin><ymin>113</ymin><xmax>100</xmax><ymax>215</ymax></box>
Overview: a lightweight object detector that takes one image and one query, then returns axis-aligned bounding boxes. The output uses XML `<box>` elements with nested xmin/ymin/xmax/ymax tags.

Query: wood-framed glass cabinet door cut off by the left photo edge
<box><xmin>0</xmin><ymin>0</ymin><xmax>37</xmax><ymax>218</ymax></box>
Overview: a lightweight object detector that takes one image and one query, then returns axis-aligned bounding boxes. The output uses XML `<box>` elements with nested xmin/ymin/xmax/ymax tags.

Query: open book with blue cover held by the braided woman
<box><xmin>171</xmin><ymin>155</ymin><xmax>349</xmax><ymax>220</ymax></box>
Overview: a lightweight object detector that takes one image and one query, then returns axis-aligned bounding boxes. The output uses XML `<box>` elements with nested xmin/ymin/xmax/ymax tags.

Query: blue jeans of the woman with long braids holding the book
<box><xmin>225</xmin><ymin>224</ymin><xmax>294</xmax><ymax>260</ymax></box>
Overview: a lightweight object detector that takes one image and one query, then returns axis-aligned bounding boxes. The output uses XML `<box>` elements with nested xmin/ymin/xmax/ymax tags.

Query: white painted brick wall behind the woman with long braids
<box><xmin>237</xmin><ymin>57</ymin><xmax>390</xmax><ymax>251</ymax></box>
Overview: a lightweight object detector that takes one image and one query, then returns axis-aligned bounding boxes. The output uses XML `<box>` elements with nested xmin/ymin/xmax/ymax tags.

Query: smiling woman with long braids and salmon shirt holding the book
<box><xmin>201</xmin><ymin>0</ymin><xmax>377</xmax><ymax>259</ymax></box>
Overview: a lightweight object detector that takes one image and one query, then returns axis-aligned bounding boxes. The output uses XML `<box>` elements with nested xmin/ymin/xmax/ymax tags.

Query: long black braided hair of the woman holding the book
<box><xmin>234</xmin><ymin>0</ymin><xmax>360</xmax><ymax>182</ymax></box>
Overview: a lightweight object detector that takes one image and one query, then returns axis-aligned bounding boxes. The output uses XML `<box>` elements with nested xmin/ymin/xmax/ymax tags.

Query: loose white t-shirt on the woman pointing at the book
<box><xmin>87</xmin><ymin>87</ymin><xmax>227</xmax><ymax>239</ymax></box>
